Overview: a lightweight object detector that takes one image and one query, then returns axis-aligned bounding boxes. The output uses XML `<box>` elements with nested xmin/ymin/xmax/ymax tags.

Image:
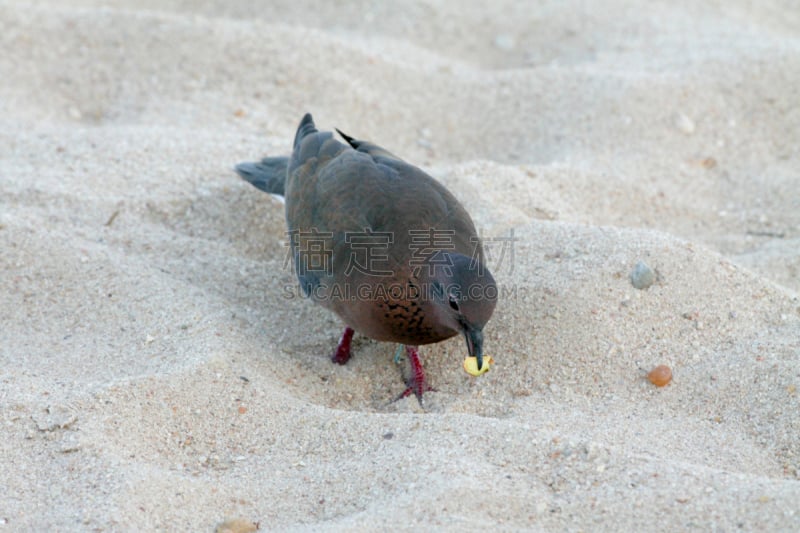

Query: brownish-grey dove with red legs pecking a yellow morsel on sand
<box><xmin>235</xmin><ymin>113</ymin><xmax>498</xmax><ymax>404</ymax></box>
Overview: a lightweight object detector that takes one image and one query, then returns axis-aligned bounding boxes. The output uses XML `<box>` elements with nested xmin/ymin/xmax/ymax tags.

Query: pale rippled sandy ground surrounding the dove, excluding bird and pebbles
<box><xmin>0</xmin><ymin>0</ymin><xmax>800</xmax><ymax>531</ymax></box>
